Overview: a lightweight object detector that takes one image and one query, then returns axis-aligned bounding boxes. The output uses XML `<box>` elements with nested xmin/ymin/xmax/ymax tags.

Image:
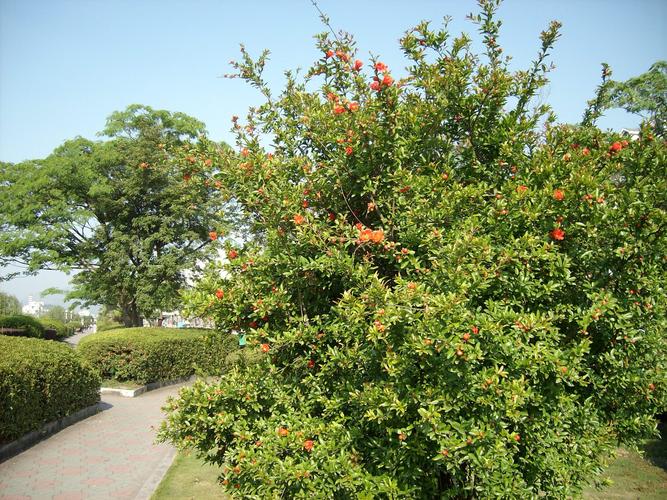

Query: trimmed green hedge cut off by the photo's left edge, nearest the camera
<box><xmin>0</xmin><ymin>335</ymin><xmax>100</xmax><ymax>442</ymax></box>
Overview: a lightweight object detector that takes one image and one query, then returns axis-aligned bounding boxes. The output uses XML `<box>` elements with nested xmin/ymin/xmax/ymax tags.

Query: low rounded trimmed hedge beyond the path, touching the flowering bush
<box><xmin>77</xmin><ymin>328</ymin><xmax>238</xmax><ymax>384</ymax></box>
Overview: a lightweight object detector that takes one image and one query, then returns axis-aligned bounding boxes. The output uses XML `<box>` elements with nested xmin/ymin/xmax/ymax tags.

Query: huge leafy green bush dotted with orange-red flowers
<box><xmin>162</xmin><ymin>1</ymin><xmax>667</xmax><ymax>498</ymax></box>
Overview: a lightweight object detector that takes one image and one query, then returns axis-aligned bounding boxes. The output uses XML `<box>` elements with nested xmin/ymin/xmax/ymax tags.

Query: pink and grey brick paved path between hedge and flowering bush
<box><xmin>0</xmin><ymin>384</ymin><xmax>184</xmax><ymax>500</ymax></box>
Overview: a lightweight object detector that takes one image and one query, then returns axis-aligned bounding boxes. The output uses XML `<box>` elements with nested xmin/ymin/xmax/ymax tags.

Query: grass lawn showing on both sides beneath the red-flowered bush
<box><xmin>151</xmin><ymin>427</ymin><xmax>667</xmax><ymax>500</ymax></box>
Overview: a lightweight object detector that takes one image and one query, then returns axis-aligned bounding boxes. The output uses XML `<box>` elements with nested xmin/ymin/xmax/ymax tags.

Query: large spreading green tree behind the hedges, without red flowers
<box><xmin>0</xmin><ymin>105</ymin><xmax>226</xmax><ymax>326</ymax></box>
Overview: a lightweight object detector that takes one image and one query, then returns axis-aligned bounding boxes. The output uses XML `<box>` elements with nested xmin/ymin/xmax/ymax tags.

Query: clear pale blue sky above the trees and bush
<box><xmin>0</xmin><ymin>0</ymin><xmax>667</xmax><ymax>302</ymax></box>
